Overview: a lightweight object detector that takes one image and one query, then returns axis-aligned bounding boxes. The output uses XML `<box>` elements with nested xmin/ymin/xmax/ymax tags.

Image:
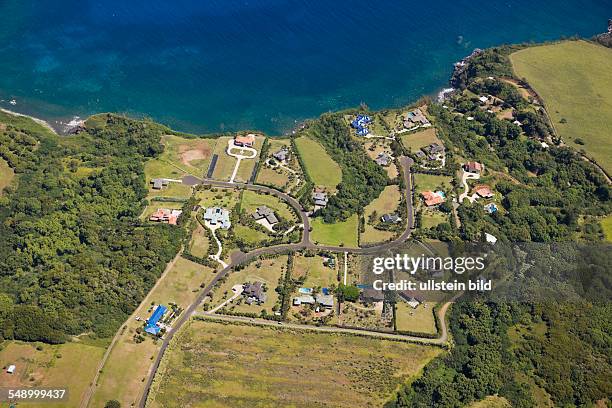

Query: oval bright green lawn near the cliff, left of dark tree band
<box><xmin>295</xmin><ymin>136</ymin><xmax>342</xmax><ymax>191</ymax></box>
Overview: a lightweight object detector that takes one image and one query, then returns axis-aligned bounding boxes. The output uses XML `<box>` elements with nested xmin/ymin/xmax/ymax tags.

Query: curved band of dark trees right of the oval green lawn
<box><xmin>307</xmin><ymin>113</ymin><xmax>389</xmax><ymax>222</ymax></box>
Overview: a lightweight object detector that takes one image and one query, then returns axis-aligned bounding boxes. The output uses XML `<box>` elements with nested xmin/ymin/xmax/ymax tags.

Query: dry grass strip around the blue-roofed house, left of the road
<box><xmin>88</xmin><ymin>257</ymin><xmax>214</xmax><ymax>407</ymax></box>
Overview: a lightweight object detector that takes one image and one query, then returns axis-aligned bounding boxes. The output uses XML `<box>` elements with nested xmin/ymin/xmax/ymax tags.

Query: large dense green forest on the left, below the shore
<box><xmin>0</xmin><ymin>115</ymin><xmax>184</xmax><ymax>343</ymax></box>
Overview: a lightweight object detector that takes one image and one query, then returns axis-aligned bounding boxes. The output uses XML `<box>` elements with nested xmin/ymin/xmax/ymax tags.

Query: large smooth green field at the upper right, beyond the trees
<box><xmin>510</xmin><ymin>41</ymin><xmax>612</xmax><ymax>173</ymax></box>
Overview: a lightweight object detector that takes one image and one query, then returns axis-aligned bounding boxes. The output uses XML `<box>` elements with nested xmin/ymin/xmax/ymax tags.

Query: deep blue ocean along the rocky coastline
<box><xmin>0</xmin><ymin>0</ymin><xmax>612</xmax><ymax>134</ymax></box>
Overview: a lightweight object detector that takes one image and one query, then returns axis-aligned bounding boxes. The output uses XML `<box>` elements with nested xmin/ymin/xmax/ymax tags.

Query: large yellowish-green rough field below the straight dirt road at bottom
<box><xmin>147</xmin><ymin>320</ymin><xmax>442</xmax><ymax>408</ymax></box>
